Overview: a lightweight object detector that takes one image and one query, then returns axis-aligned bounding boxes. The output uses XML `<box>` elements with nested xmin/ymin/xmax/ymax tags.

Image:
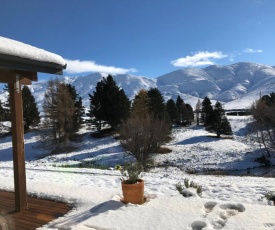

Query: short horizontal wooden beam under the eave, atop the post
<box><xmin>0</xmin><ymin>70</ymin><xmax>37</xmax><ymax>85</ymax></box>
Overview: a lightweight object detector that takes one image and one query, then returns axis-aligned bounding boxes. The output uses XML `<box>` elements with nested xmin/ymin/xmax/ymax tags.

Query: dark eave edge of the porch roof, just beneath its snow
<box><xmin>0</xmin><ymin>53</ymin><xmax>66</xmax><ymax>75</ymax></box>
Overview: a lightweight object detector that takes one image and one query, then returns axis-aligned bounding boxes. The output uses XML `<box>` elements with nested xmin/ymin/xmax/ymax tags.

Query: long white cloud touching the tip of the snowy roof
<box><xmin>65</xmin><ymin>59</ymin><xmax>137</xmax><ymax>74</ymax></box>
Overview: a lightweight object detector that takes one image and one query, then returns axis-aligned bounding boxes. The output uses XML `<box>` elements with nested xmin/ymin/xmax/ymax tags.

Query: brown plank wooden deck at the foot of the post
<box><xmin>0</xmin><ymin>191</ymin><xmax>71</xmax><ymax>230</ymax></box>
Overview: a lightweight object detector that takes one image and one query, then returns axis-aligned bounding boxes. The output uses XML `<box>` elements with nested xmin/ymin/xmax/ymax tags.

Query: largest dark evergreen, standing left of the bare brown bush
<box><xmin>89</xmin><ymin>75</ymin><xmax>130</xmax><ymax>129</ymax></box>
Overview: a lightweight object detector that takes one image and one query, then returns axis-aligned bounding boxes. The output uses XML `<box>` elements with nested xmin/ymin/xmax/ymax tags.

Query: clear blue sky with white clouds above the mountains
<box><xmin>0</xmin><ymin>0</ymin><xmax>275</xmax><ymax>78</ymax></box>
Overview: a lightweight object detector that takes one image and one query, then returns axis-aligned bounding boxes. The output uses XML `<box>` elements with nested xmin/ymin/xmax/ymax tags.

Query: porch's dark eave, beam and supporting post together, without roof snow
<box><xmin>0</xmin><ymin>40</ymin><xmax>66</xmax><ymax>213</ymax></box>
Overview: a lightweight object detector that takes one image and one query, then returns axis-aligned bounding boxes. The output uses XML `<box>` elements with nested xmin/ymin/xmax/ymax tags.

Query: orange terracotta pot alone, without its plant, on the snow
<box><xmin>121</xmin><ymin>179</ymin><xmax>144</xmax><ymax>204</ymax></box>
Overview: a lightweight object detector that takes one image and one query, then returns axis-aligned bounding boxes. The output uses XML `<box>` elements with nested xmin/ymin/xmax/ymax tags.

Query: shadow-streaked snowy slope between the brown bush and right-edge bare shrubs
<box><xmin>156</xmin><ymin>116</ymin><xmax>268</xmax><ymax>171</ymax></box>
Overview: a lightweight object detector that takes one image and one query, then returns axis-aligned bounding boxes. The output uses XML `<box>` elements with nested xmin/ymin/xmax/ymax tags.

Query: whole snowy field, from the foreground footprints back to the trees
<box><xmin>0</xmin><ymin>117</ymin><xmax>275</xmax><ymax>230</ymax></box>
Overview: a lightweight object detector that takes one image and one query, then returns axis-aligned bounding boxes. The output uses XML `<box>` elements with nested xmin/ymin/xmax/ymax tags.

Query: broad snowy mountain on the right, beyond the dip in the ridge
<box><xmin>157</xmin><ymin>62</ymin><xmax>275</xmax><ymax>109</ymax></box>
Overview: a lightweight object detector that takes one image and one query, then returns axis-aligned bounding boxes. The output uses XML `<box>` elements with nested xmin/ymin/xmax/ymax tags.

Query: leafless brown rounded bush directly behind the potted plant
<box><xmin>119</xmin><ymin>114</ymin><xmax>170</xmax><ymax>171</ymax></box>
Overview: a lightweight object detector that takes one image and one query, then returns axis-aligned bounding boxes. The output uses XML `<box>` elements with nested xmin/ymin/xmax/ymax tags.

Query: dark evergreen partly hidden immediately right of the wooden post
<box><xmin>22</xmin><ymin>86</ymin><xmax>40</xmax><ymax>130</ymax></box>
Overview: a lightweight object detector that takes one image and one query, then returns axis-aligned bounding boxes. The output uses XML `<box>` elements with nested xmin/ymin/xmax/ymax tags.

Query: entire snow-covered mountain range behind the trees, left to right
<box><xmin>0</xmin><ymin>62</ymin><xmax>275</xmax><ymax>109</ymax></box>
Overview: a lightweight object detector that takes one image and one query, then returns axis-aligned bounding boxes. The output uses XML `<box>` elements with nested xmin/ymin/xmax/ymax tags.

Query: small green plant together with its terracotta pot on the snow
<box><xmin>120</xmin><ymin>163</ymin><xmax>144</xmax><ymax>204</ymax></box>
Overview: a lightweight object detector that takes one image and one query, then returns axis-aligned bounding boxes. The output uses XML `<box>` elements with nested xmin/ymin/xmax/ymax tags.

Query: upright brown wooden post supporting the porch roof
<box><xmin>8</xmin><ymin>79</ymin><xmax>28</xmax><ymax>212</ymax></box>
